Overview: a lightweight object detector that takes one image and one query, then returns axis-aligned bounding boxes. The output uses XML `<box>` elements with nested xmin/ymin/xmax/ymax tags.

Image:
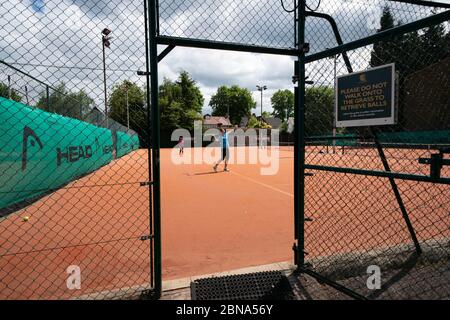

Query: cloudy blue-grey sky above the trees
<box><xmin>0</xmin><ymin>0</ymin><xmax>450</xmax><ymax>114</ymax></box>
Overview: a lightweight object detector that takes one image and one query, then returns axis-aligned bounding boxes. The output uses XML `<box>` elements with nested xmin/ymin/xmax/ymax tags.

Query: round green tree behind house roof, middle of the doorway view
<box><xmin>209</xmin><ymin>85</ymin><xmax>256</xmax><ymax>124</ymax></box>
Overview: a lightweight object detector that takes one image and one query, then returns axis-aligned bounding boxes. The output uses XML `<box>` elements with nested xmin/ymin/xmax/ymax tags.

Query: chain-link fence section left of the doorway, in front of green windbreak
<box><xmin>0</xmin><ymin>0</ymin><xmax>161</xmax><ymax>299</ymax></box>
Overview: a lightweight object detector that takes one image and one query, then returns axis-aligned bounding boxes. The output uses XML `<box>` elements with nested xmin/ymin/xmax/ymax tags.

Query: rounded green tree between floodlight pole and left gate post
<box><xmin>108</xmin><ymin>80</ymin><xmax>148</xmax><ymax>139</ymax></box>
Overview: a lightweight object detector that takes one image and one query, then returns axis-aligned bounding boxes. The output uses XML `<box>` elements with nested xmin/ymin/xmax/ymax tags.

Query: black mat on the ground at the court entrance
<box><xmin>191</xmin><ymin>271</ymin><xmax>293</xmax><ymax>300</ymax></box>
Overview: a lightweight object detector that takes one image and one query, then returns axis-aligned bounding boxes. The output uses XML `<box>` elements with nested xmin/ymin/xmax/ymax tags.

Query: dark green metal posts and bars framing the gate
<box><xmin>148</xmin><ymin>0</ymin><xmax>450</xmax><ymax>299</ymax></box>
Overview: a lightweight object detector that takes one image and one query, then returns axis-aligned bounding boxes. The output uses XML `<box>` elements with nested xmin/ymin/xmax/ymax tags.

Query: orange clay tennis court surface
<box><xmin>0</xmin><ymin>147</ymin><xmax>450</xmax><ymax>299</ymax></box>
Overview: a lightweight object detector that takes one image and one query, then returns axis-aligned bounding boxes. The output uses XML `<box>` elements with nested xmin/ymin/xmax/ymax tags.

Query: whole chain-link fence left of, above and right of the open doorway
<box><xmin>0</xmin><ymin>0</ymin><xmax>450</xmax><ymax>299</ymax></box>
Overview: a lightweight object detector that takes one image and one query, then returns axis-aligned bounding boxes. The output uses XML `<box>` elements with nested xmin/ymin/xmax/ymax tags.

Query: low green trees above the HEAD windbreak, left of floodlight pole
<box><xmin>36</xmin><ymin>82</ymin><xmax>94</xmax><ymax>119</ymax></box>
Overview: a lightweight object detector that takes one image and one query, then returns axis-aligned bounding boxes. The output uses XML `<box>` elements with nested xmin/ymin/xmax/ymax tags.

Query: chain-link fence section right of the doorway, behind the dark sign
<box><xmin>305</xmin><ymin>1</ymin><xmax>450</xmax><ymax>299</ymax></box>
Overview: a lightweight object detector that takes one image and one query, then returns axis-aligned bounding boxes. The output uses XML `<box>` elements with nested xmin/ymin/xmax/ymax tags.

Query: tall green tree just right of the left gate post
<box><xmin>159</xmin><ymin>71</ymin><xmax>204</xmax><ymax>131</ymax></box>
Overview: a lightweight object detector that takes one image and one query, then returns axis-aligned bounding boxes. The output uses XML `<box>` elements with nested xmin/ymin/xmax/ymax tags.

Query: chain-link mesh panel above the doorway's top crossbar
<box><xmin>159</xmin><ymin>0</ymin><xmax>295</xmax><ymax>48</ymax></box>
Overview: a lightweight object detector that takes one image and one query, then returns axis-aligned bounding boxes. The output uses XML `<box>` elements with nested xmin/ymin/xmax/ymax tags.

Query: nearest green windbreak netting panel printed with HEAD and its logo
<box><xmin>0</xmin><ymin>97</ymin><xmax>112</xmax><ymax>208</ymax></box>
